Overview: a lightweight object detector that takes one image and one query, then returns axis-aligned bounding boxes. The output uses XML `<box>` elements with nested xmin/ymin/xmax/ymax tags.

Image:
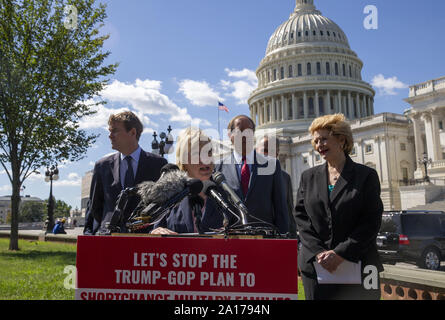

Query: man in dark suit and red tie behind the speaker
<box><xmin>215</xmin><ymin>115</ymin><xmax>289</xmax><ymax>234</ymax></box>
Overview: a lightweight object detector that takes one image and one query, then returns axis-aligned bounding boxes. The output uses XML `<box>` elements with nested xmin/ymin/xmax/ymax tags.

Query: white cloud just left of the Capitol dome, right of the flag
<box><xmin>221</xmin><ymin>68</ymin><xmax>258</xmax><ymax>105</ymax></box>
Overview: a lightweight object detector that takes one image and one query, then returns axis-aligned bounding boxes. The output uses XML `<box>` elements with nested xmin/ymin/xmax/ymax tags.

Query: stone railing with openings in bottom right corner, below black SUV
<box><xmin>380</xmin><ymin>265</ymin><xmax>445</xmax><ymax>300</ymax></box>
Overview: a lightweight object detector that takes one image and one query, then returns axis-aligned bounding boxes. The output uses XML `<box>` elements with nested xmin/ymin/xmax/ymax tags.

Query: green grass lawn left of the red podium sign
<box><xmin>0</xmin><ymin>238</ymin><xmax>76</xmax><ymax>300</ymax></box>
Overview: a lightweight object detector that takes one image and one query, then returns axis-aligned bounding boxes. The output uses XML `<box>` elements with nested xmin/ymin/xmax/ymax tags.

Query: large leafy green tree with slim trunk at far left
<box><xmin>0</xmin><ymin>0</ymin><xmax>117</xmax><ymax>250</ymax></box>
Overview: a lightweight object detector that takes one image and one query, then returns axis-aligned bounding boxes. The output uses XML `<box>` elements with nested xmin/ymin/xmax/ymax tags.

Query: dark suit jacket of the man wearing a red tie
<box><xmin>215</xmin><ymin>152</ymin><xmax>289</xmax><ymax>234</ymax></box>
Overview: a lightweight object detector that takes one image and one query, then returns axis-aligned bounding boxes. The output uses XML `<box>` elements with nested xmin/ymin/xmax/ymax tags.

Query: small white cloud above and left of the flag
<box><xmin>179</xmin><ymin>79</ymin><xmax>222</xmax><ymax>107</ymax></box>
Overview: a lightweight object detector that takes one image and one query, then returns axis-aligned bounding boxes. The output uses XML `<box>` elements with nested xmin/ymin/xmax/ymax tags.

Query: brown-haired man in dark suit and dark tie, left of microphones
<box><xmin>84</xmin><ymin>112</ymin><xmax>167</xmax><ymax>235</ymax></box>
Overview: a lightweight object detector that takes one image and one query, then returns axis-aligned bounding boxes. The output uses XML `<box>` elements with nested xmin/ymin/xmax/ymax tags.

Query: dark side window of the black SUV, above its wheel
<box><xmin>402</xmin><ymin>214</ymin><xmax>441</xmax><ymax>236</ymax></box>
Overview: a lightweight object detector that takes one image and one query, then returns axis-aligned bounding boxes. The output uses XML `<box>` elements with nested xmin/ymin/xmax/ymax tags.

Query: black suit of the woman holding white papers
<box><xmin>295</xmin><ymin>156</ymin><xmax>383</xmax><ymax>299</ymax></box>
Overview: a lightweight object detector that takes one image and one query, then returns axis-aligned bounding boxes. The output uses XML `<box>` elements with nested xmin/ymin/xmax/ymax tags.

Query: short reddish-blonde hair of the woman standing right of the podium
<box><xmin>309</xmin><ymin>113</ymin><xmax>354</xmax><ymax>155</ymax></box>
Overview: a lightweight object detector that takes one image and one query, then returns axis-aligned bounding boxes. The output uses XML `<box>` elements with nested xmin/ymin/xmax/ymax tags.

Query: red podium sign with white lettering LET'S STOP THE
<box><xmin>76</xmin><ymin>236</ymin><xmax>298</xmax><ymax>300</ymax></box>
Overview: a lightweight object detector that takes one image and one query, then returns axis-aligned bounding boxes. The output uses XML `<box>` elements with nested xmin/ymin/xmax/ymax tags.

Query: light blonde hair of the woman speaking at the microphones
<box><xmin>176</xmin><ymin>127</ymin><xmax>213</xmax><ymax>171</ymax></box>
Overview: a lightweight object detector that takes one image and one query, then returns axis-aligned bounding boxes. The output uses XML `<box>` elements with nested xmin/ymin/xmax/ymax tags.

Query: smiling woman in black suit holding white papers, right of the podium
<box><xmin>295</xmin><ymin>114</ymin><xmax>383</xmax><ymax>300</ymax></box>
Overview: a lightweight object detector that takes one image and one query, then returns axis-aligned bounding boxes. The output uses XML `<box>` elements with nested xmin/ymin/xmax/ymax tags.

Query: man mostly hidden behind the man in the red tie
<box><xmin>256</xmin><ymin>135</ymin><xmax>297</xmax><ymax>239</ymax></box>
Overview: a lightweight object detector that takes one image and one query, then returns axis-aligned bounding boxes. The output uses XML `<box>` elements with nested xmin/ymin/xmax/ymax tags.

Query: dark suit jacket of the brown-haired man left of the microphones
<box><xmin>84</xmin><ymin>150</ymin><xmax>167</xmax><ymax>234</ymax></box>
